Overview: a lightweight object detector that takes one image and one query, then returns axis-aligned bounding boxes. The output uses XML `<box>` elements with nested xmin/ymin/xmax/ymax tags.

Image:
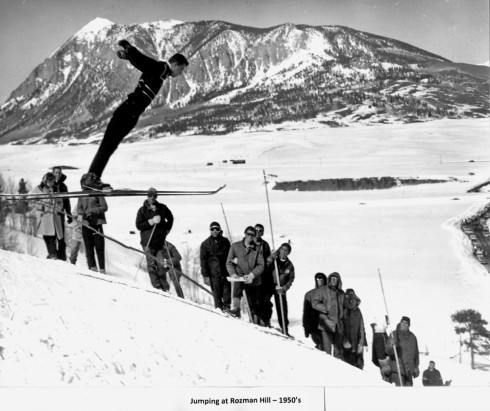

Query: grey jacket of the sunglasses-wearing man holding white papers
<box><xmin>226</xmin><ymin>239</ymin><xmax>265</xmax><ymax>286</ymax></box>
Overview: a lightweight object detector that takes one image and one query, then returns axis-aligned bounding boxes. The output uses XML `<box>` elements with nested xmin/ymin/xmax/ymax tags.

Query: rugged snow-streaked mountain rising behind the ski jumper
<box><xmin>0</xmin><ymin>18</ymin><xmax>490</xmax><ymax>144</ymax></box>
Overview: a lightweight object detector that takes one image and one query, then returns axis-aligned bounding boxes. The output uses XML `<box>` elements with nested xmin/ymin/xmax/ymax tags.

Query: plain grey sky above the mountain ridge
<box><xmin>0</xmin><ymin>0</ymin><xmax>489</xmax><ymax>102</ymax></box>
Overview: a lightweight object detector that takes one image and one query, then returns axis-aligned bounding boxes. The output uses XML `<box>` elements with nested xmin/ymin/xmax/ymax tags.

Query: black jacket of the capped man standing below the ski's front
<box><xmin>136</xmin><ymin>200</ymin><xmax>174</xmax><ymax>250</ymax></box>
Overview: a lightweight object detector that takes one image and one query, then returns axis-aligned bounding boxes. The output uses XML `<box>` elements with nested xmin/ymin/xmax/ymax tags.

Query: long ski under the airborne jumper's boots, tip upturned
<box><xmin>0</xmin><ymin>184</ymin><xmax>226</xmax><ymax>200</ymax></box>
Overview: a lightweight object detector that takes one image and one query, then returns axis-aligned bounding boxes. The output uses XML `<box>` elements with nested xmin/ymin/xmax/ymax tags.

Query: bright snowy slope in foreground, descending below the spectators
<box><xmin>0</xmin><ymin>251</ymin><xmax>385</xmax><ymax>387</ymax></box>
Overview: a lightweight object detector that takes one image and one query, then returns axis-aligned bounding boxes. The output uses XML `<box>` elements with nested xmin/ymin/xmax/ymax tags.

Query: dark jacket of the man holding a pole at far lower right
<box><xmin>386</xmin><ymin>324</ymin><xmax>419</xmax><ymax>377</ymax></box>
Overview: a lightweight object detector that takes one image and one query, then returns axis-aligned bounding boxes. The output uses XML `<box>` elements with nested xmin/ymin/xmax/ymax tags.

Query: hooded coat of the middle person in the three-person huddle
<box><xmin>312</xmin><ymin>273</ymin><xmax>345</xmax><ymax>334</ymax></box>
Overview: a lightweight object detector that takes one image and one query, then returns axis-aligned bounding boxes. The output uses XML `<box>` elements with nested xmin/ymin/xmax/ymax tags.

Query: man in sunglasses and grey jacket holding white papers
<box><xmin>226</xmin><ymin>226</ymin><xmax>265</xmax><ymax>323</ymax></box>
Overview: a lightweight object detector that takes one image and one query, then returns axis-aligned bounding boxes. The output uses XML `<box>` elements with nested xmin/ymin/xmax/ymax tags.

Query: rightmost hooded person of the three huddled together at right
<box><xmin>343</xmin><ymin>288</ymin><xmax>367</xmax><ymax>370</ymax></box>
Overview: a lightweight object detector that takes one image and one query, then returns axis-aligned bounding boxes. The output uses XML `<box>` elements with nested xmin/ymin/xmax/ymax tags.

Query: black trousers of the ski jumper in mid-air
<box><xmin>88</xmin><ymin>100</ymin><xmax>147</xmax><ymax>177</ymax></box>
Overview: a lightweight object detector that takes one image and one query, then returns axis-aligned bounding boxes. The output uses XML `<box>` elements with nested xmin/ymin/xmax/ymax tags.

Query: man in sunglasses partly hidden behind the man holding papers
<box><xmin>254</xmin><ymin>223</ymin><xmax>275</xmax><ymax>328</ymax></box>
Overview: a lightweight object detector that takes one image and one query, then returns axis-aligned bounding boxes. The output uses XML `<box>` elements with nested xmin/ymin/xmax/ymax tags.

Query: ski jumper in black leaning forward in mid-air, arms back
<box><xmin>82</xmin><ymin>40</ymin><xmax>189</xmax><ymax>189</ymax></box>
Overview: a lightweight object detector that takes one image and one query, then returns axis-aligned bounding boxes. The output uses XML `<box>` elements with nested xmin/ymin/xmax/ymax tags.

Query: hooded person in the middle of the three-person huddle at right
<box><xmin>312</xmin><ymin>272</ymin><xmax>344</xmax><ymax>359</ymax></box>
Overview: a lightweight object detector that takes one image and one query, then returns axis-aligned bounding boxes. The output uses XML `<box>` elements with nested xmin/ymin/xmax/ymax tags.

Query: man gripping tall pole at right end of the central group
<box><xmin>267</xmin><ymin>243</ymin><xmax>295</xmax><ymax>335</ymax></box>
